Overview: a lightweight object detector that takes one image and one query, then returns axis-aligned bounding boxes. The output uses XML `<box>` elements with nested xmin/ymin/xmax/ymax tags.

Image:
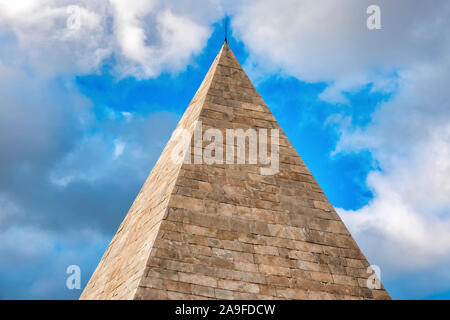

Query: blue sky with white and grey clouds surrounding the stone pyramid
<box><xmin>0</xmin><ymin>0</ymin><xmax>450</xmax><ymax>299</ymax></box>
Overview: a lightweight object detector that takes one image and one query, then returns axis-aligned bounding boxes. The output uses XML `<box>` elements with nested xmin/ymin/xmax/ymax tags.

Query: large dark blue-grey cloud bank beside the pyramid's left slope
<box><xmin>0</xmin><ymin>64</ymin><xmax>178</xmax><ymax>298</ymax></box>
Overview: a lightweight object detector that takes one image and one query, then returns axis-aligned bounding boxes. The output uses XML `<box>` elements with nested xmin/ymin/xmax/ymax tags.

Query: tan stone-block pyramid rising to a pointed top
<box><xmin>81</xmin><ymin>43</ymin><xmax>390</xmax><ymax>299</ymax></box>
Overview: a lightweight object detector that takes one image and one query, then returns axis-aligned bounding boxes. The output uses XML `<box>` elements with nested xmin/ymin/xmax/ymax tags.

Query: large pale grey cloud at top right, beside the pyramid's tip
<box><xmin>229</xmin><ymin>0</ymin><xmax>449</xmax><ymax>102</ymax></box>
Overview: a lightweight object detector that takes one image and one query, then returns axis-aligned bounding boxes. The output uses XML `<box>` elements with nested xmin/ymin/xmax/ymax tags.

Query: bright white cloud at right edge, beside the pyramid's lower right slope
<box><xmin>336</xmin><ymin>63</ymin><xmax>450</xmax><ymax>271</ymax></box>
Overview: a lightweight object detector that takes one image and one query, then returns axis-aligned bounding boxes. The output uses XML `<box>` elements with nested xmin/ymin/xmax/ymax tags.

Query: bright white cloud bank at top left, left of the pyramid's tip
<box><xmin>0</xmin><ymin>0</ymin><xmax>222</xmax><ymax>78</ymax></box>
